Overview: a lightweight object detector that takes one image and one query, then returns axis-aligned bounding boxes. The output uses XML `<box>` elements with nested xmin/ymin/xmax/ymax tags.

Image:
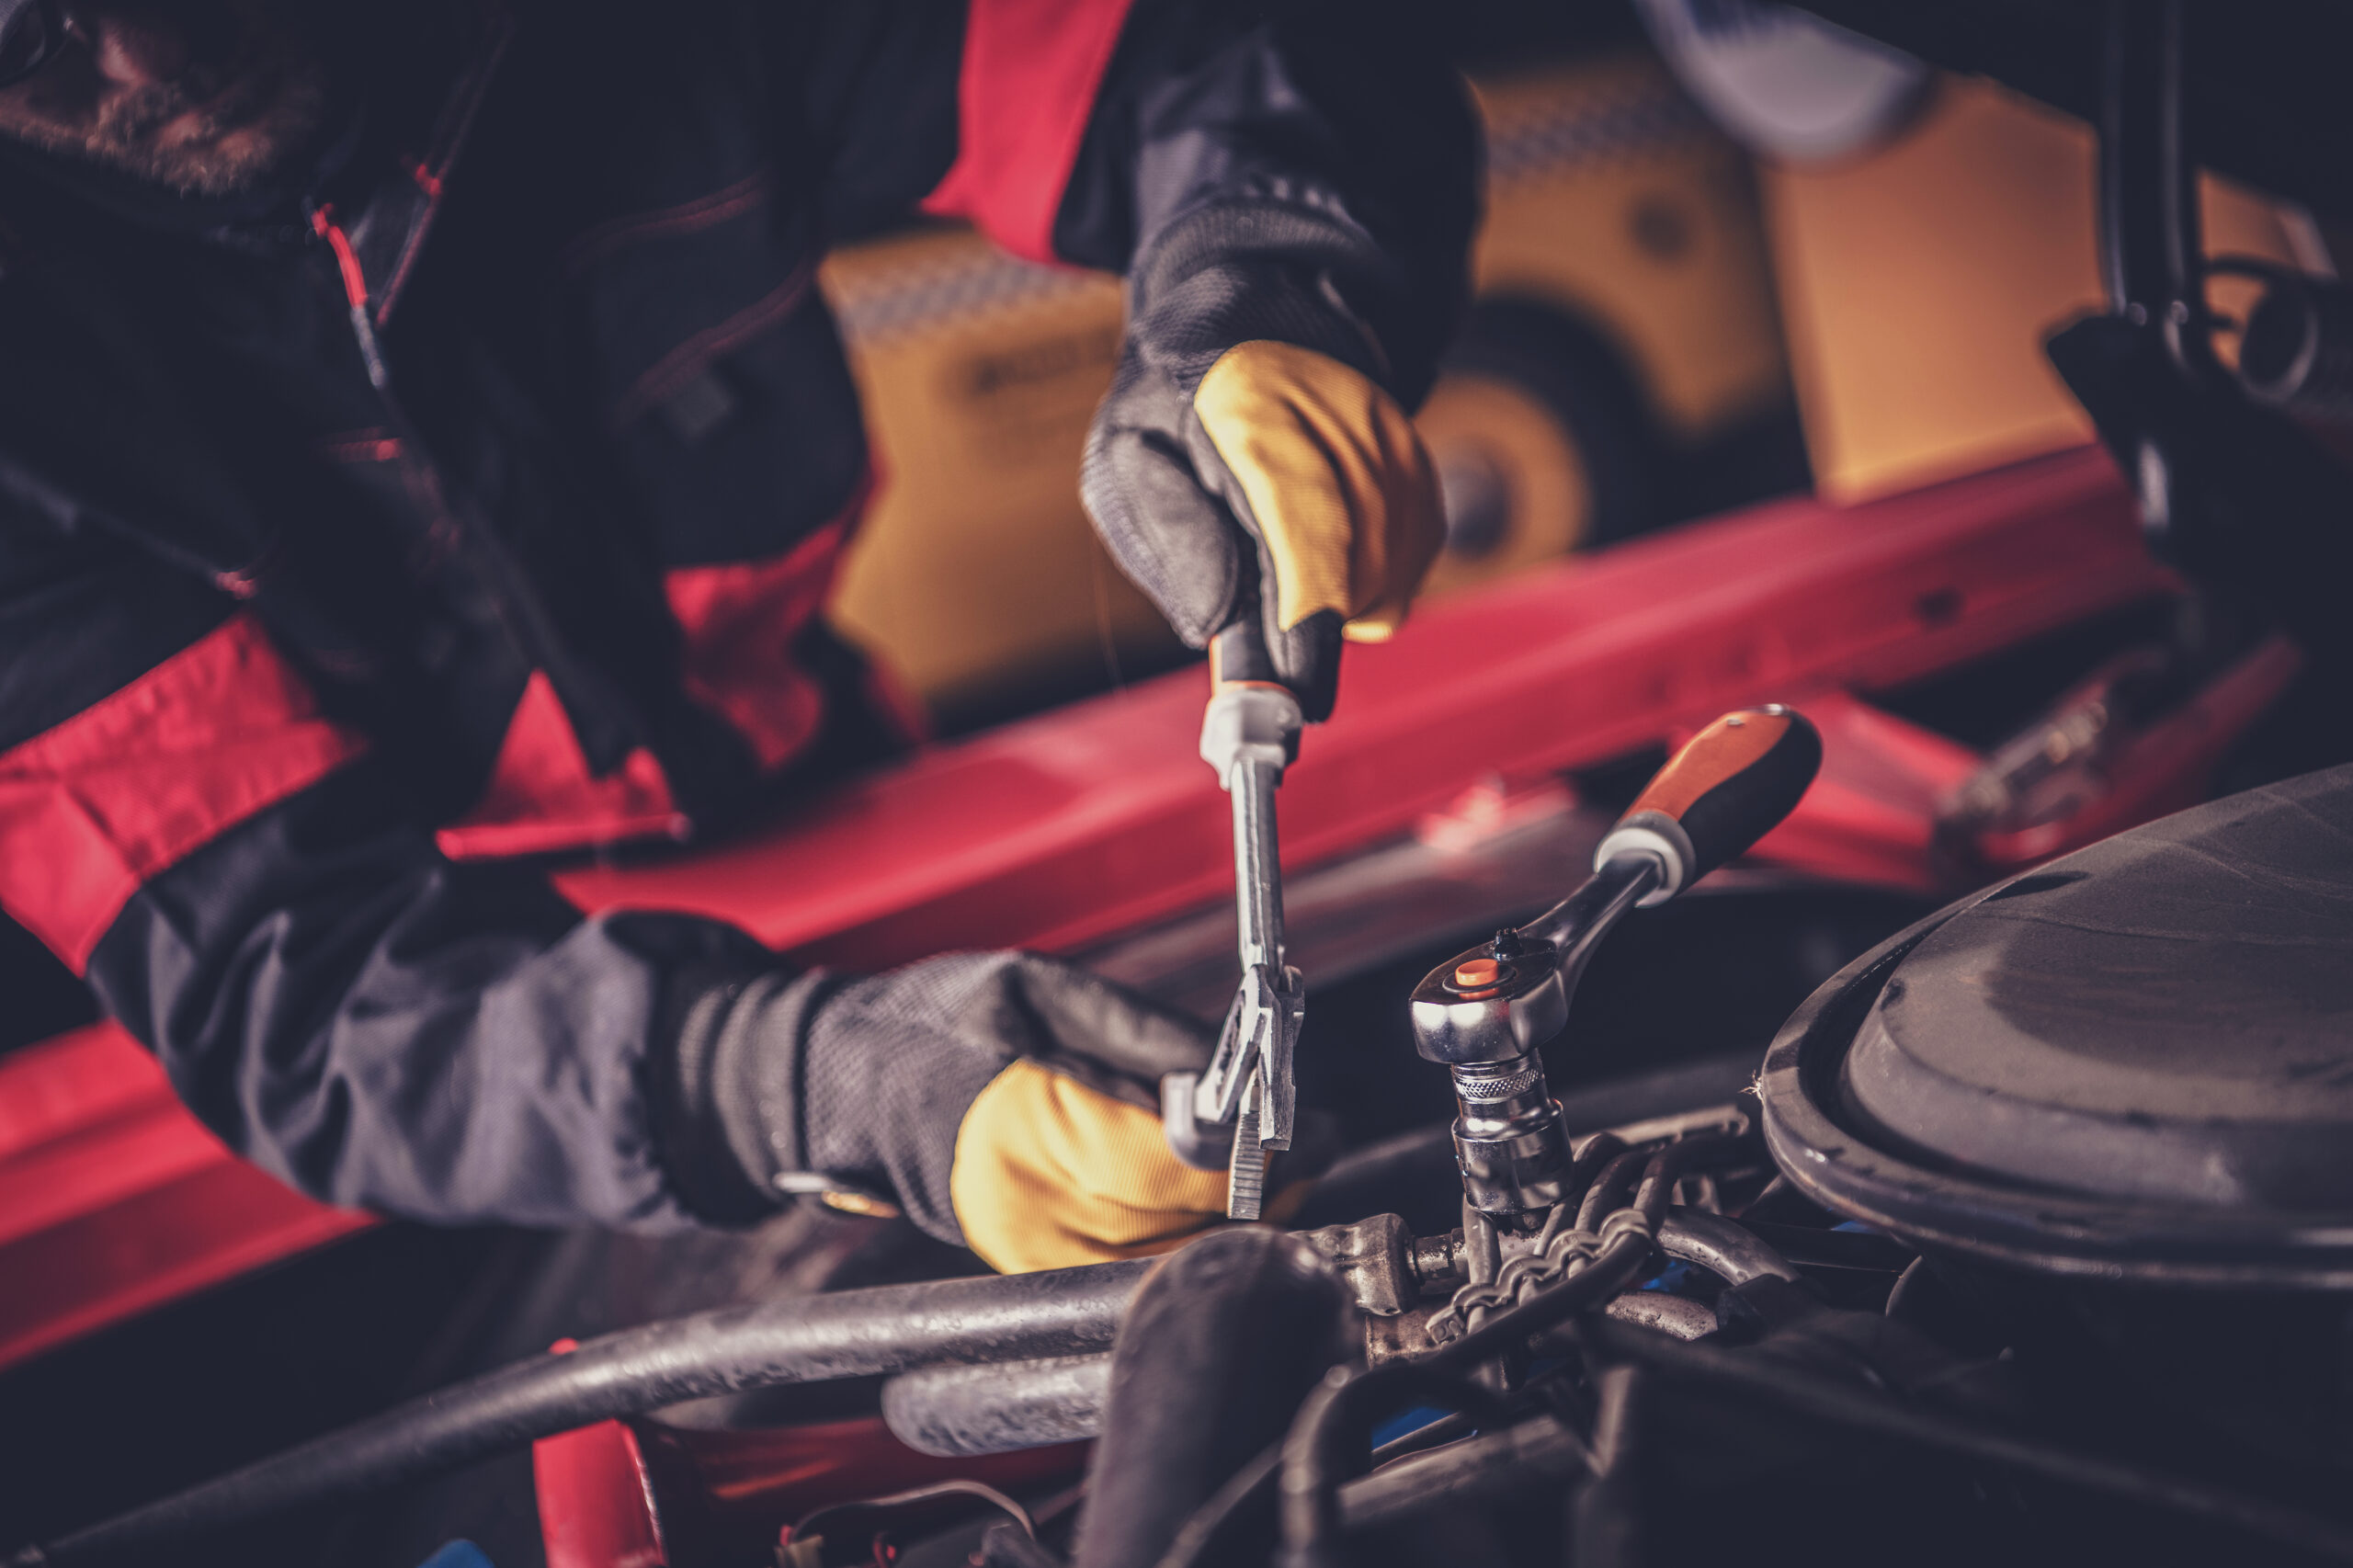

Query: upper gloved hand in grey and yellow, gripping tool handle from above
<box><xmin>1080</xmin><ymin>205</ymin><xmax>1445</xmax><ymax>721</ymax></box>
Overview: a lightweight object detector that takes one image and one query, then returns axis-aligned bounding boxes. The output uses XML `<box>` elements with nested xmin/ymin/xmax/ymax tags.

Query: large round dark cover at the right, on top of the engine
<box><xmin>1760</xmin><ymin>767</ymin><xmax>2353</xmax><ymax>1286</ymax></box>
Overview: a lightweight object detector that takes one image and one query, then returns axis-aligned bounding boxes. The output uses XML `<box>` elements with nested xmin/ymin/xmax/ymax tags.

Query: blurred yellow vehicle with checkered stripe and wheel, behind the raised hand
<box><xmin>821</xmin><ymin>56</ymin><xmax>1789</xmax><ymax>721</ymax></box>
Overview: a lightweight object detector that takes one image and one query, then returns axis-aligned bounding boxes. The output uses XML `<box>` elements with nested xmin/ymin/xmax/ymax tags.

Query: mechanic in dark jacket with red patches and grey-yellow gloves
<box><xmin>0</xmin><ymin>0</ymin><xmax>1478</xmax><ymax>1269</ymax></box>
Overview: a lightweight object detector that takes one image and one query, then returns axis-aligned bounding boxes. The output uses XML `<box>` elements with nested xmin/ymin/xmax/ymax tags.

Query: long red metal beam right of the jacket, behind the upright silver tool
<box><xmin>558</xmin><ymin>449</ymin><xmax>2172</xmax><ymax>965</ymax></box>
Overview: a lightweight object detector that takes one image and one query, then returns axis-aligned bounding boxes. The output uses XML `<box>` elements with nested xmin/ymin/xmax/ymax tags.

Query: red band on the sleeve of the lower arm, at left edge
<box><xmin>0</xmin><ymin>612</ymin><xmax>367</xmax><ymax>972</ymax></box>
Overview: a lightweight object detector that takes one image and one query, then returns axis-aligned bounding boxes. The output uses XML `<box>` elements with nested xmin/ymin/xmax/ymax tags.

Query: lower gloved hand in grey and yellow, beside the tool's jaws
<box><xmin>661</xmin><ymin>953</ymin><xmax>1226</xmax><ymax>1274</ymax></box>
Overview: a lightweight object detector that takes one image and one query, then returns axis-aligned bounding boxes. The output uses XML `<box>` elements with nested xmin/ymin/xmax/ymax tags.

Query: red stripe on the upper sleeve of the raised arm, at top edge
<box><xmin>923</xmin><ymin>0</ymin><xmax>1130</xmax><ymax>261</ymax></box>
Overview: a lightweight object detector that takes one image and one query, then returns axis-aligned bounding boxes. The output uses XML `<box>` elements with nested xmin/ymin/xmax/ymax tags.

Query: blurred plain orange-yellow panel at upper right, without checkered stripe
<box><xmin>1762</xmin><ymin>78</ymin><xmax>2325</xmax><ymax>502</ymax></box>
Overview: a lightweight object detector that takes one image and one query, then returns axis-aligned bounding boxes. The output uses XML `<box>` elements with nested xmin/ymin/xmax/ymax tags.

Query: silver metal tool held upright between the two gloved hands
<box><xmin>1160</xmin><ymin>609</ymin><xmax>1308</xmax><ymax>1220</ymax></box>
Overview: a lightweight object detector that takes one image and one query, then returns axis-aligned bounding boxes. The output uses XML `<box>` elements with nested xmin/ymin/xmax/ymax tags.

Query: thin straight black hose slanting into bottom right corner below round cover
<box><xmin>1562</xmin><ymin>1297</ymin><xmax>2353</xmax><ymax>1561</ymax></box>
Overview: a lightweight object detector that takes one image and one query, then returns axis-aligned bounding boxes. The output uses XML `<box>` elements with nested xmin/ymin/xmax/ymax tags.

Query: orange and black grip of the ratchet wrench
<box><xmin>1593</xmin><ymin>704</ymin><xmax>1821</xmax><ymax>906</ymax></box>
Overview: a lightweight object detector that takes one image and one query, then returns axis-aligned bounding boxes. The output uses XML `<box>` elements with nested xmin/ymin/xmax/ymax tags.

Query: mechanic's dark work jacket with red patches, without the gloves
<box><xmin>0</xmin><ymin>0</ymin><xmax>1471</xmax><ymax>1224</ymax></box>
